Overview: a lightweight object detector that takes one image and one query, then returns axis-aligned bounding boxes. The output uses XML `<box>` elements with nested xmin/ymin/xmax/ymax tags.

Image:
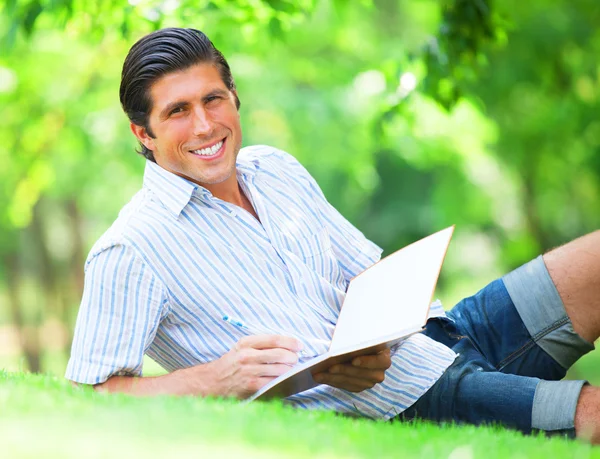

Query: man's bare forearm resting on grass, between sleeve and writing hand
<box><xmin>94</xmin><ymin>363</ymin><xmax>223</xmax><ymax>397</ymax></box>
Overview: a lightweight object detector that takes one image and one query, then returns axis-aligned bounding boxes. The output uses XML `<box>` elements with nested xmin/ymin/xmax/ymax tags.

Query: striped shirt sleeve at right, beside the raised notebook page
<box><xmin>268</xmin><ymin>150</ymin><xmax>383</xmax><ymax>281</ymax></box>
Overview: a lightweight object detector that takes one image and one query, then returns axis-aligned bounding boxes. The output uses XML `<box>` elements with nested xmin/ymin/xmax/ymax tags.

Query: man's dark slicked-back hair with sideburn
<box><xmin>119</xmin><ymin>28</ymin><xmax>240</xmax><ymax>162</ymax></box>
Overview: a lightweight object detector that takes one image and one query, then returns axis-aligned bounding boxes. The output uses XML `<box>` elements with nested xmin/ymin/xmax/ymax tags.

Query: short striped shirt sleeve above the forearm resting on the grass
<box><xmin>65</xmin><ymin>244</ymin><xmax>166</xmax><ymax>384</ymax></box>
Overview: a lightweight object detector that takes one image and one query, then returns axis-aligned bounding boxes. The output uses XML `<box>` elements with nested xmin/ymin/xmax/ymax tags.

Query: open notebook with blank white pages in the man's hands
<box><xmin>248</xmin><ymin>226</ymin><xmax>454</xmax><ymax>401</ymax></box>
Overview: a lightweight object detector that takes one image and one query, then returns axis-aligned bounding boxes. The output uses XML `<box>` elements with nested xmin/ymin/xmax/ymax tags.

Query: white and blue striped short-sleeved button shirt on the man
<box><xmin>66</xmin><ymin>146</ymin><xmax>455</xmax><ymax>419</ymax></box>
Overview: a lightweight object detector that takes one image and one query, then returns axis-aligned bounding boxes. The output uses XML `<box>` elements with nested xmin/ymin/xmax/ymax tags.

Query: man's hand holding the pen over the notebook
<box><xmin>209</xmin><ymin>335</ymin><xmax>302</xmax><ymax>399</ymax></box>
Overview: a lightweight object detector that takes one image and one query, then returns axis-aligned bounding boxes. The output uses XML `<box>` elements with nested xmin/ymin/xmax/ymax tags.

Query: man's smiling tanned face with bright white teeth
<box><xmin>132</xmin><ymin>63</ymin><xmax>242</xmax><ymax>190</ymax></box>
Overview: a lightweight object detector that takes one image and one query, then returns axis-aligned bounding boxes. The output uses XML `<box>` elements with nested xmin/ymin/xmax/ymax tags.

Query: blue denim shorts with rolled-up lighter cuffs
<box><xmin>400</xmin><ymin>257</ymin><xmax>594</xmax><ymax>436</ymax></box>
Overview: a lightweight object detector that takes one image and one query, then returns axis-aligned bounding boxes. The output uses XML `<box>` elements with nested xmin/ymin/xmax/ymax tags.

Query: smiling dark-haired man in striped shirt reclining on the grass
<box><xmin>66</xmin><ymin>29</ymin><xmax>600</xmax><ymax>440</ymax></box>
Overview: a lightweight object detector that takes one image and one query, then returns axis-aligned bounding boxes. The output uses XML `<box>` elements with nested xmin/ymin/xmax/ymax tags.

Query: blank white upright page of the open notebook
<box><xmin>329</xmin><ymin>226</ymin><xmax>454</xmax><ymax>354</ymax></box>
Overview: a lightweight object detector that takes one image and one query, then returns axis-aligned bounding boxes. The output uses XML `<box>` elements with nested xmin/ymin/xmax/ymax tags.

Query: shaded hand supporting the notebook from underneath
<box><xmin>313</xmin><ymin>349</ymin><xmax>392</xmax><ymax>392</ymax></box>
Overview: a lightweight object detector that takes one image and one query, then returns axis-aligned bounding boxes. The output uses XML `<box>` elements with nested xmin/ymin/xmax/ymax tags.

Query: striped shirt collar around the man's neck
<box><xmin>144</xmin><ymin>155</ymin><xmax>259</xmax><ymax>217</ymax></box>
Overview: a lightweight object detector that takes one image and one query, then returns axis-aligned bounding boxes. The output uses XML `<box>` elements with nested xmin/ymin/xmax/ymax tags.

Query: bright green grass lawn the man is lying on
<box><xmin>0</xmin><ymin>371</ymin><xmax>600</xmax><ymax>459</ymax></box>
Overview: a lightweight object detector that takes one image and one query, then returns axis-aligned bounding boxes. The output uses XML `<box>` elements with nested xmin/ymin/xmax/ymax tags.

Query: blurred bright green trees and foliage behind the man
<box><xmin>0</xmin><ymin>0</ymin><xmax>600</xmax><ymax>383</ymax></box>
